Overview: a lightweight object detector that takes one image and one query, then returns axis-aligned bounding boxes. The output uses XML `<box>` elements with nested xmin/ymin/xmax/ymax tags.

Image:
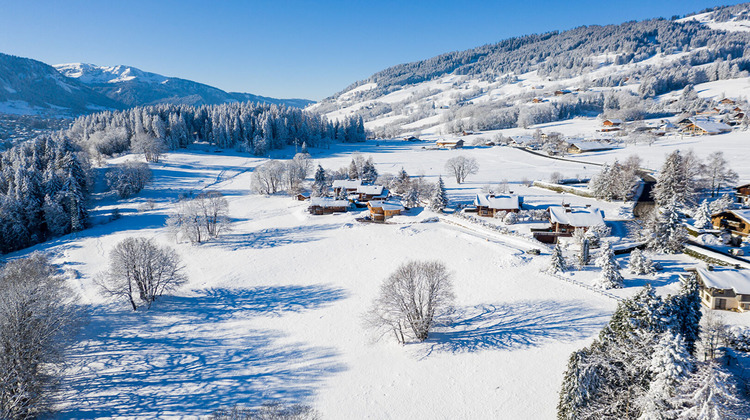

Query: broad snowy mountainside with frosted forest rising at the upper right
<box><xmin>310</xmin><ymin>3</ymin><xmax>750</xmax><ymax>137</ymax></box>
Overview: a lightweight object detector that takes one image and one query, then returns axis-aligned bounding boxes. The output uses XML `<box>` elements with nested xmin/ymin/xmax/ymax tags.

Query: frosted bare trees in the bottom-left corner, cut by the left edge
<box><xmin>0</xmin><ymin>253</ymin><xmax>80</xmax><ymax>419</ymax></box>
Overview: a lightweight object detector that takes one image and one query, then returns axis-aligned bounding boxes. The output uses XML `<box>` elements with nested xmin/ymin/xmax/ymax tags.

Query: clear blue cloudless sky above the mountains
<box><xmin>0</xmin><ymin>0</ymin><xmax>737</xmax><ymax>100</ymax></box>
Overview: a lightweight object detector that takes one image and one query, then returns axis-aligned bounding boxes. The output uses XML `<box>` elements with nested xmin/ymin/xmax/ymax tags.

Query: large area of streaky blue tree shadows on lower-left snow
<box><xmin>58</xmin><ymin>286</ymin><xmax>345</xmax><ymax>418</ymax></box>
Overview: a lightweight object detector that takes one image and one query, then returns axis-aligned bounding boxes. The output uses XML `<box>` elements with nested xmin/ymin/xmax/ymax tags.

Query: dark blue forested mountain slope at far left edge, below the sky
<box><xmin>0</xmin><ymin>53</ymin><xmax>122</xmax><ymax>115</ymax></box>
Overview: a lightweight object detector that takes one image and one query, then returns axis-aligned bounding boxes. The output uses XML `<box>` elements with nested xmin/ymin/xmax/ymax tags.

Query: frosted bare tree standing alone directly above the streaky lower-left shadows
<box><xmin>98</xmin><ymin>238</ymin><xmax>187</xmax><ymax>311</ymax></box>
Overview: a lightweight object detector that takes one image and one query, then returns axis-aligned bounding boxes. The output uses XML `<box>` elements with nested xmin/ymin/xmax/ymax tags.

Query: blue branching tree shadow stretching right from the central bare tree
<box><xmin>428</xmin><ymin>300</ymin><xmax>611</xmax><ymax>354</ymax></box>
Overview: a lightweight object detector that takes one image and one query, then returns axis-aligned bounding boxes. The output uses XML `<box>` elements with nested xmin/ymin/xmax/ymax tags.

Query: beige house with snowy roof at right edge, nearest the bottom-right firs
<box><xmin>690</xmin><ymin>267</ymin><xmax>750</xmax><ymax>312</ymax></box>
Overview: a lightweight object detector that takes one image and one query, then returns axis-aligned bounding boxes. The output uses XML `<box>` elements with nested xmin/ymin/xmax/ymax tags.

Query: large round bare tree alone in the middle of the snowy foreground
<box><xmin>365</xmin><ymin>261</ymin><xmax>454</xmax><ymax>344</ymax></box>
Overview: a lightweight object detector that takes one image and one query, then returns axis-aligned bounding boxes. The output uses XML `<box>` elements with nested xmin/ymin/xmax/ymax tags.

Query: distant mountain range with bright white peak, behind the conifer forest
<box><xmin>54</xmin><ymin>63</ymin><xmax>312</xmax><ymax>107</ymax></box>
